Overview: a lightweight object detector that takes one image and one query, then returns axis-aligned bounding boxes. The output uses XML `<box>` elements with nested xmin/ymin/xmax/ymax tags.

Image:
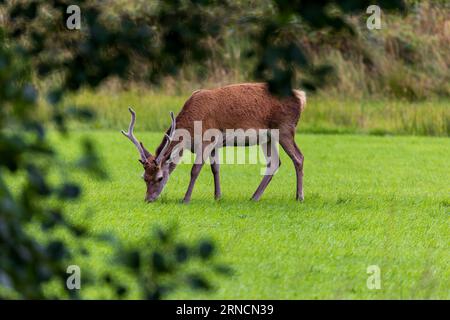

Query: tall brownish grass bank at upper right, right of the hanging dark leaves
<box><xmin>320</xmin><ymin>1</ymin><xmax>450</xmax><ymax>101</ymax></box>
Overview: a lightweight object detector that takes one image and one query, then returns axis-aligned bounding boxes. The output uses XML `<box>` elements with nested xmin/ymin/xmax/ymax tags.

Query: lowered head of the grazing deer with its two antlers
<box><xmin>122</xmin><ymin>108</ymin><xmax>176</xmax><ymax>202</ymax></box>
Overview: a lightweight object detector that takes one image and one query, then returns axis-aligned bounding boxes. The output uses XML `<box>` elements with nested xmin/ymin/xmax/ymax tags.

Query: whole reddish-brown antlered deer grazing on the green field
<box><xmin>121</xmin><ymin>83</ymin><xmax>306</xmax><ymax>203</ymax></box>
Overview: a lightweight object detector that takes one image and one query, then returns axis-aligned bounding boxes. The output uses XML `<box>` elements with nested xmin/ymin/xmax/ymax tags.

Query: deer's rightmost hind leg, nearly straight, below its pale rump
<box><xmin>280</xmin><ymin>128</ymin><xmax>304</xmax><ymax>201</ymax></box>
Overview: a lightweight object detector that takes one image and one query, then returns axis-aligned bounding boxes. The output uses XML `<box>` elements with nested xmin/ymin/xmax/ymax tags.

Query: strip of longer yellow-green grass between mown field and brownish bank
<box><xmin>40</xmin><ymin>89</ymin><xmax>450</xmax><ymax>136</ymax></box>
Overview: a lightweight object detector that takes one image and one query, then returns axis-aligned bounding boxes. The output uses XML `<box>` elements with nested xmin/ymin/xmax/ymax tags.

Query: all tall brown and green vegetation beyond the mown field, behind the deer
<box><xmin>39</xmin><ymin>1</ymin><xmax>450</xmax><ymax>136</ymax></box>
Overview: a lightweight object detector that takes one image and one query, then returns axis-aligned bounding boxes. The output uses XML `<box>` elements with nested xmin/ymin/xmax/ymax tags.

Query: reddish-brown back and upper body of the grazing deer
<box><xmin>177</xmin><ymin>83</ymin><xmax>304</xmax><ymax>130</ymax></box>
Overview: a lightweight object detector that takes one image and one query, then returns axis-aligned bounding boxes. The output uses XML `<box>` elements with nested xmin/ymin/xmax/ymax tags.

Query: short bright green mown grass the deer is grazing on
<box><xmin>44</xmin><ymin>131</ymin><xmax>450</xmax><ymax>299</ymax></box>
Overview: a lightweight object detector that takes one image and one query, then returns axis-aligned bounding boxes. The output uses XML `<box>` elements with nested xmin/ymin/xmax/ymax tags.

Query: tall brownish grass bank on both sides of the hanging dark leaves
<box><xmin>139</xmin><ymin>1</ymin><xmax>450</xmax><ymax>101</ymax></box>
